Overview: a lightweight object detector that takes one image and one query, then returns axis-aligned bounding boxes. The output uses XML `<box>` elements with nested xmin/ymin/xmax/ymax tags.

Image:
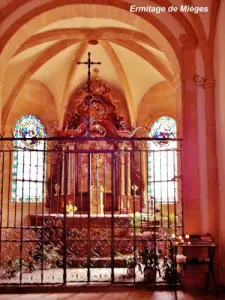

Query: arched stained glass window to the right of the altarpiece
<box><xmin>148</xmin><ymin>116</ymin><xmax>177</xmax><ymax>203</ymax></box>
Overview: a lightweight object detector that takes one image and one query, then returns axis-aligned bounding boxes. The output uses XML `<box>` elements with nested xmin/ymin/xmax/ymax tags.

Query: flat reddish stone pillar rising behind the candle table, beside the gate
<box><xmin>180</xmin><ymin>35</ymin><xmax>201</xmax><ymax>233</ymax></box>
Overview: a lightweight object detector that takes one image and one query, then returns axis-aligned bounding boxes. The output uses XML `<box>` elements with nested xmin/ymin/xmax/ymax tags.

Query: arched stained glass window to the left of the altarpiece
<box><xmin>12</xmin><ymin>115</ymin><xmax>47</xmax><ymax>202</ymax></box>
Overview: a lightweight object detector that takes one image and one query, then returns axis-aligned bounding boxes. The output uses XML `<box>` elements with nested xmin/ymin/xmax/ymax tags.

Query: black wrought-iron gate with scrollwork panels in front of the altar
<box><xmin>0</xmin><ymin>138</ymin><xmax>183</xmax><ymax>285</ymax></box>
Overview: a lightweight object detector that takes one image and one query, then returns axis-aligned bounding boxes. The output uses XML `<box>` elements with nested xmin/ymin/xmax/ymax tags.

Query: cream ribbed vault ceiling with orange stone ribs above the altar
<box><xmin>3</xmin><ymin>18</ymin><xmax>176</xmax><ymax>125</ymax></box>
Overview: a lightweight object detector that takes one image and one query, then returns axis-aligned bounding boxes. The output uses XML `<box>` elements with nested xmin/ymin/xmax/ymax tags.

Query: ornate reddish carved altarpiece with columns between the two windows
<box><xmin>47</xmin><ymin>69</ymin><xmax>144</xmax><ymax>215</ymax></box>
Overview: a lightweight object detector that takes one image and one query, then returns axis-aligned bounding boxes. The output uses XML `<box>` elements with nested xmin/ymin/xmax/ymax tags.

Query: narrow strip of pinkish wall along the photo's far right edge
<box><xmin>212</xmin><ymin>0</ymin><xmax>225</xmax><ymax>284</ymax></box>
